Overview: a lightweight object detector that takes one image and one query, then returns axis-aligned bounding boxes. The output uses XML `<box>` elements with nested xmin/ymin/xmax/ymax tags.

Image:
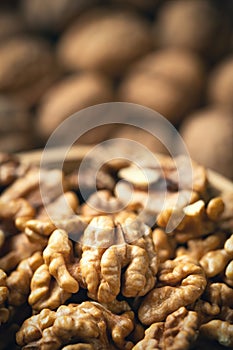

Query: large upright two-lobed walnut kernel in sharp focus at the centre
<box><xmin>80</xmin><ymin>213</ymin><xmax>158</xmax><ymax>302</ymax></box>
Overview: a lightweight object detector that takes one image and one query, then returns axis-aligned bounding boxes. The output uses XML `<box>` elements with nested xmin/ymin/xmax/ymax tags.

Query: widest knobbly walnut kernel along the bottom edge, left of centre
<box><xmin>16</xmin><ymin>301</ymin><xmax>134</xmax><ymax>350</ymax></box>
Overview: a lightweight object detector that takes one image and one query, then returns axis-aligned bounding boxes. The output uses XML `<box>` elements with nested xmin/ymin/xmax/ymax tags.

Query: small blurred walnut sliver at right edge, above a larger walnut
<box><xmin>207</xmin><ymin>56</ymin><xmax>233</xmax><ymax>109</ymax></box>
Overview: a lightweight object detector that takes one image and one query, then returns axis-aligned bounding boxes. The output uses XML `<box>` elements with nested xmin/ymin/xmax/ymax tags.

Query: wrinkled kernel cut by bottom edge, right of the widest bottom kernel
<box><xmin>133</xmin><ymin>307</ymin><xmax>198</xmax><ymax>350</ymax></box>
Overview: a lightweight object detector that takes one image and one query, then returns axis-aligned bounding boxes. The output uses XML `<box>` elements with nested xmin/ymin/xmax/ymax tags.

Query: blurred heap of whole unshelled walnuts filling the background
<box><xmin>0</xmin><ymin>0</ymin><xmax>233</xmax><ymax>178</ymax></box>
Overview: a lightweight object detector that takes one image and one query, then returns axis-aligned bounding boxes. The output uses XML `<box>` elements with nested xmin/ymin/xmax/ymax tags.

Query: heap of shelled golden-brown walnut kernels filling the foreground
<box><xmin>0</xmin><ymin>154</ymin><xmax>233</xmax><ymax>350</ymax></box>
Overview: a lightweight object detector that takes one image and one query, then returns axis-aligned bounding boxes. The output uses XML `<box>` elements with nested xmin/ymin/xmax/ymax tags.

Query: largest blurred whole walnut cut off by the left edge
<box><xmin>0</xmin><ymin>36</ymin><xmax>58</xmax><ymax>105</ymax></box>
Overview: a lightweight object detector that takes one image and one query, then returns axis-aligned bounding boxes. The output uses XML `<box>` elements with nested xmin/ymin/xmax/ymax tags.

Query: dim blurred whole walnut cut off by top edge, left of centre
<box><xmin>21</xmin><ymin>0</ymin><xmax>97</xmax><ymax>32</ymax></box>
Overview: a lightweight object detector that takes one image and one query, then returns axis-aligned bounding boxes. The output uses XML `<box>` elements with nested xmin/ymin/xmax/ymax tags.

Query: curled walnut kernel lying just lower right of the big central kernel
<box><xmin>138</xmin><ymin>256</ymin><xmax>206</xmax><ymax>325</ymax></box>
